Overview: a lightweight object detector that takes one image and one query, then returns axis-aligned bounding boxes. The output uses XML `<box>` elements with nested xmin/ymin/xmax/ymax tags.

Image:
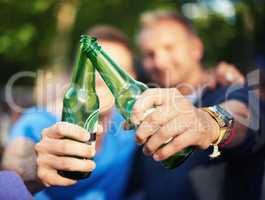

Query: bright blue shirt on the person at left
<box><xmin>10</xmin><ymin>108</ymin><xmax>136</xmax><ymax>200</ymax></box>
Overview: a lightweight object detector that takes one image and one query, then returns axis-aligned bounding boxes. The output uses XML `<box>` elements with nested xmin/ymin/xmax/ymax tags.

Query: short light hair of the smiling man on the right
<box><xmin>140</xmin><ymin>9</ymin><xmax>196</xmax><ymax>35</ymax></box>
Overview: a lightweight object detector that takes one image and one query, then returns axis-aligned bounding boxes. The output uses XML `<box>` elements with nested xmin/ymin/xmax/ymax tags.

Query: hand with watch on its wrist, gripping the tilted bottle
<box><xmin>131</xmin><ymin>88</ymin><xmax>219</xmax><ymax>161</ymax></box>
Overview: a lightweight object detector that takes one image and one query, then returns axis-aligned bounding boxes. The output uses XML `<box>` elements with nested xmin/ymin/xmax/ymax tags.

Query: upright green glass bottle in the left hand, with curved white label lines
<box><xmin>58</xmin><ymin>38</ymin><xmax>99</xmax><ymax>180</ymax></box>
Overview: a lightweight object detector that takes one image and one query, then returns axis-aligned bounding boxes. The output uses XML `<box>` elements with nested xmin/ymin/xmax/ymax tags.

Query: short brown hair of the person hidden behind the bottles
<box><xmin>88</xmin><ymin>25</ymin><xmax>131</xmax><ymax>51</ymax></box>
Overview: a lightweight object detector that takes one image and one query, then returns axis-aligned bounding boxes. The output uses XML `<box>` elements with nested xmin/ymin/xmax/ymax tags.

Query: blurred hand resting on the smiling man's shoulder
<box><xmin>207</xmin><ymin>62</ymin><xmax>245</xmax><ymax>89</ymax></box>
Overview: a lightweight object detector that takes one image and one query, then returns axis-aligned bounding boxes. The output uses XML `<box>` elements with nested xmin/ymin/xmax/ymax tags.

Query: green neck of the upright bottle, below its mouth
<box><xmin>72</xmin><ymin>47</ymin><xmax>95</xmax><ymax>92</ymax></box>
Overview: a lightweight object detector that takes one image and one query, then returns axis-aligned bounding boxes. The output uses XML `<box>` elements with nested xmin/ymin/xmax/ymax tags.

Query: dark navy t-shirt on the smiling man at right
<box><xmin>126</xmin><ymin>87</ymin><xmax>264</xmax><ymax>200</ymax></box>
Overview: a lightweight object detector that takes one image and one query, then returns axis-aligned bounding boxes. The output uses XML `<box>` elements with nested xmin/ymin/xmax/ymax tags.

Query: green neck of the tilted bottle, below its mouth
<box><xmin>85</xmin><ymin>42</ymin><xmax>141</xmax><ymax>97</ymax></box>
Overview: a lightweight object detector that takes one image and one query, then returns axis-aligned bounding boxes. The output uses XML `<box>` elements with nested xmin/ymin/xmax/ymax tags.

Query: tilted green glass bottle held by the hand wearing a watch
<box><xmin>83</xmin><ymin>36</ymin><xmax>193</xmax><ymax>169</ymax></box>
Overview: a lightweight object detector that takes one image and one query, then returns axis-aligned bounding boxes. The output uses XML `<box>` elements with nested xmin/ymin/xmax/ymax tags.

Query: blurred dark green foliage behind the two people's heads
<box><xmin>0</xmin><ymin>0</ymin><xmax>265</xmax><ymax>85</ymax></box>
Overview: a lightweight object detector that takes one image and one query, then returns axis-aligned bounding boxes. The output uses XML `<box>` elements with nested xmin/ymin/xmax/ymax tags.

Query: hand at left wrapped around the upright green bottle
<box><xmin>35</xmin><ymin>122</ymin><xmax>96</xmax><ymax>186</ymax></box>
